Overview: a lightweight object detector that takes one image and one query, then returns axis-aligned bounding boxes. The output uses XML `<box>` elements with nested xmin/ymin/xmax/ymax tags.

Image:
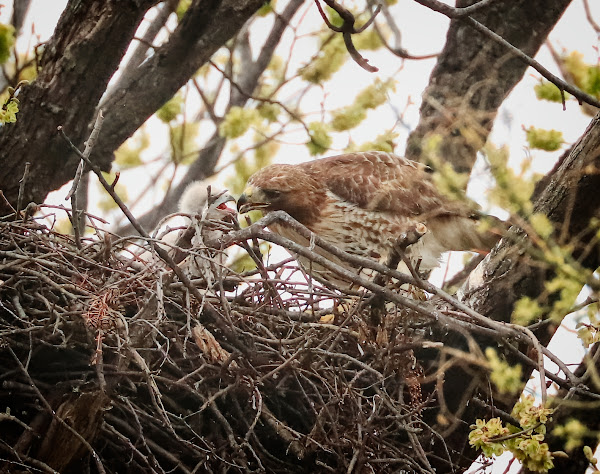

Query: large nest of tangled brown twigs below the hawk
<box><xmin>0</xmin><ymin>211</ymin><xmax>454</xmax><ymax>473</ymax></box>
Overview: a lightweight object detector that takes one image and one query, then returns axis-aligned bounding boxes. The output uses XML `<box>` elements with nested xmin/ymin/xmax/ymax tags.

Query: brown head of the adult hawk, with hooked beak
<box><xmin>237</xmin><ymin>165</ymin><xmax>326</xmax><ymax>225</ymax></box>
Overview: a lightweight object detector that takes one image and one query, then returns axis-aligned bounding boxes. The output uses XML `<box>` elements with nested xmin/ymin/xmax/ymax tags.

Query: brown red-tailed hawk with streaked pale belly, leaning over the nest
<box><xmin>238</xmin><ymin>151</ymin><xmax>499</xmax><ymax>282</ymax></box>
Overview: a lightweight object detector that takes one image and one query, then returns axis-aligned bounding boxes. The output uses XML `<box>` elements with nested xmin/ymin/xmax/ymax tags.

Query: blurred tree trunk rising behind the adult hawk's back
<box><xmin>406</xmin><ymin>0</ymin><xmax>571</xmax><ymax>173</ymax></box>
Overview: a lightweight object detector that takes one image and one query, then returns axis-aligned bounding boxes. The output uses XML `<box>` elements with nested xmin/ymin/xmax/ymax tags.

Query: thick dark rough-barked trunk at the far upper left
<box><xmin>0</xmin><ymin>0</ymin><xmax>156</xmax><ymax>214</ymax></box>
